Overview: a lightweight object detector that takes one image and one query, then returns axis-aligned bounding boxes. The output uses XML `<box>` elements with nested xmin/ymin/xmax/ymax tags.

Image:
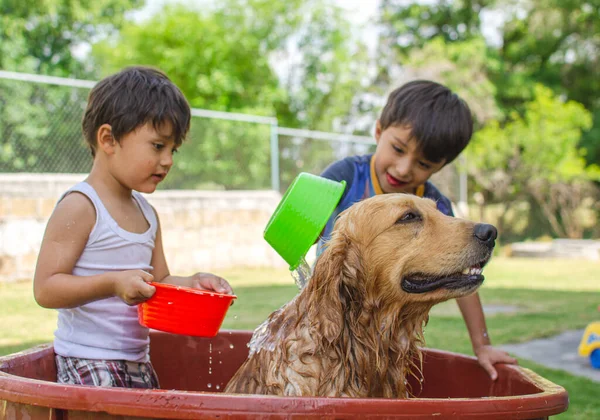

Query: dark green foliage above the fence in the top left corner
<box><xmin>0</xmin><ymin>0</ymin><xmax>143</xmax><ymax>77</ymax></box>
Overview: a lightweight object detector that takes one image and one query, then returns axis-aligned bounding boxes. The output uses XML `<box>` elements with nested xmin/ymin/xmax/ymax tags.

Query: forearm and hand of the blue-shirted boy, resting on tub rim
<box><xmin>456</xmin><ymin>293</ymin><xmax>517</xmax><ymax>380</ymax></box>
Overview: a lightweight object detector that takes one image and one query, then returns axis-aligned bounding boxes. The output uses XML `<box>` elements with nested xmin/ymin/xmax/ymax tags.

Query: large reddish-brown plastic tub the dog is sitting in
<box><xmin>0</xmin><ymin>331</ymin><xmax>568</xmax><ymax>420</ymax></box>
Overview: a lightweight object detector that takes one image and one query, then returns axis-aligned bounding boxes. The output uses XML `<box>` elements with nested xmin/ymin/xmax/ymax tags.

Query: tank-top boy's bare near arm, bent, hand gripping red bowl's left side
<box><xmin>33</xmin><ymin>193</ymin><xmax>154</xmax><ymax>308</ymax></box>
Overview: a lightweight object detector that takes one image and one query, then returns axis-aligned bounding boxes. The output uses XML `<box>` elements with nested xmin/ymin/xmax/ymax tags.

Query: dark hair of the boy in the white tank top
<box><xmin>82</xmin><ymin>66</ymin><xmax>191</xmax><ymax>156</ymax></box>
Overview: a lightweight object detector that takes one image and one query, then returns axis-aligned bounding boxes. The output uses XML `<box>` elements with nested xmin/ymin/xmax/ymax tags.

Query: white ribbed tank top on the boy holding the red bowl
<box><xmin>54</xmin><ymin>182</ymin><xmax>158</xmax><ymax>362</ymax></box>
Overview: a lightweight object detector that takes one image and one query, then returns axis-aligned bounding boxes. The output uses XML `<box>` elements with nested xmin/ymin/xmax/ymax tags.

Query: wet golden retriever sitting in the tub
<box><xmin>225</xmin><ymin>194</ymin><xmax>497</xmax><ymax>398</ymax></box>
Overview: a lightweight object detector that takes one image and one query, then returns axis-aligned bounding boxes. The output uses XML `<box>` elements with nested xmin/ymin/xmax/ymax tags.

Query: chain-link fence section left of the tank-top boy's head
<box><xmin>0</xmin><ymin>79</ymin><xmax>92</xmax><ymax>173</ymax></box>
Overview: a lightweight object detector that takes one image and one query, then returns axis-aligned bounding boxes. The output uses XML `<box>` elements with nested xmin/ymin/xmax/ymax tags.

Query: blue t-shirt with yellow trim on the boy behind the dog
<box><xmin>317</xmin><ymin>154</ymin><xmax>454</xmax><ymax>255</ymax></box>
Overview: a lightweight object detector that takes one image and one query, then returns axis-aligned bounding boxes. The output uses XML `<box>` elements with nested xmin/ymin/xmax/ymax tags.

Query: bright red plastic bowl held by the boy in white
<box><xmin>138</xmin><ymin>283</ymin><xmax>237</xmax><ymax>337</ymax></box>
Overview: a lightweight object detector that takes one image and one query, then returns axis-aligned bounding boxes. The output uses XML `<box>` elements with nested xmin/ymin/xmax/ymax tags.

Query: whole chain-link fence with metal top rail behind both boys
<box><xmin>0</xmin><ymin>71</ymin><xmax>460</xmax><ymax>201</ymax></box>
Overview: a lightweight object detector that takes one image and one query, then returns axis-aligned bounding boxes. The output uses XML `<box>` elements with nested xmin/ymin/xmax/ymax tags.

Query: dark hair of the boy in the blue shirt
<box><xmin>379</xmin><ymin>80</ymin><xmax>473</xmax><ymax>163</ymax></box>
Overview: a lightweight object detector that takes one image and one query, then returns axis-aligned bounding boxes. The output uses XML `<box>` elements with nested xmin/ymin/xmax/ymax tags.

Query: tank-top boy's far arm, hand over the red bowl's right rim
<box><xmin>151</xmin><ymin>208</ymin><xmax>233</xmax><ymax>294</ymax></box>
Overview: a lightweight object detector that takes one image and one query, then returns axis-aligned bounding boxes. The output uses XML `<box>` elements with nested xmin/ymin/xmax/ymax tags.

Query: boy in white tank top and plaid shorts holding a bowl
<box><xmin>33</xmin><ymin>67</ymin><xmax>232</xmax><ymax>388</ymax></box>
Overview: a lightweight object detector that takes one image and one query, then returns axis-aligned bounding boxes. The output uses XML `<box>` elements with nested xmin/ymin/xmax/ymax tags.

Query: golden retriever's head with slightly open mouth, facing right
<box><xmin>315</xmin><ymin>194</ymin><xmax>497</xmax><ymax>314</ymax></box>
